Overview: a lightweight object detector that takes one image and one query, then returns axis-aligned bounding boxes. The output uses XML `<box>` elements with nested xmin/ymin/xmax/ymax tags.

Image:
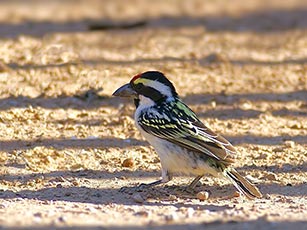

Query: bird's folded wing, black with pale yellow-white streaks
<box><xmin>137</xmin><ymin>101</ymin><xmax>235</xmax><ymax>164</ymax></box>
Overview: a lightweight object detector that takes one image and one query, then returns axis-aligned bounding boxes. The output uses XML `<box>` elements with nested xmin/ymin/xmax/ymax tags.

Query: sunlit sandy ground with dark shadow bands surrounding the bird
<box><xmin>0</xmin><ymin>0</ymin><xmax>307</xmax><ymax>230</ymax></box>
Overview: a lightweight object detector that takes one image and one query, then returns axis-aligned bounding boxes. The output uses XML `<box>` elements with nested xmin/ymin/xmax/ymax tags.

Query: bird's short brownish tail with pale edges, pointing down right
<box><xmin>224</xmin><ymin>168</ymin><xmax>262</xmax><ymax>199</ymax></box>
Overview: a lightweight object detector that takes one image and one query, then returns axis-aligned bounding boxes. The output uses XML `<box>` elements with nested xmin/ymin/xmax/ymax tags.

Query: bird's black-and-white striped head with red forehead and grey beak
<box><xmin>113</xmin><ymin>71</ymin><xmax>177</xmax><ymax>106</ymax></box>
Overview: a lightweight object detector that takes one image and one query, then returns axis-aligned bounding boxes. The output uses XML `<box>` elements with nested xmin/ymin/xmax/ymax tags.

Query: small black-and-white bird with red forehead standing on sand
<box><xmin>113</xmin><ymin>71</ymin><xmax>262</xmax><ymax>199</ymax></box>
